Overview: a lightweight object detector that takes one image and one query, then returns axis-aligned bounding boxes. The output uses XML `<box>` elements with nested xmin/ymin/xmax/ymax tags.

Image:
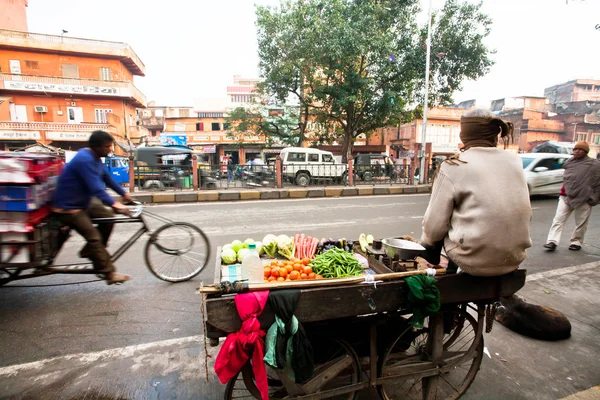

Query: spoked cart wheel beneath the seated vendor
<box><xmin>377</xmin><ymin>307</ymin><xmax>483</xmax><ymax>400</ymax></box>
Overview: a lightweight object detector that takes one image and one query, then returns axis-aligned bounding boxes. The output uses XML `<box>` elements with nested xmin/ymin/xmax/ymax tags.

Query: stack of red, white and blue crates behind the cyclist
<box><xmin>0</xmin><ymin>152</ymin><xmax>63</xmax><ymax>263</ymax></box>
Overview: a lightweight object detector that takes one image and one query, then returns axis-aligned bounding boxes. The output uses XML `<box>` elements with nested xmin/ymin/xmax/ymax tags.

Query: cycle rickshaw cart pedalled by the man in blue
<box><xmin>0</xmin><ymin>203</ymin><xmax>210</xmax><ymax>286</ymax></box>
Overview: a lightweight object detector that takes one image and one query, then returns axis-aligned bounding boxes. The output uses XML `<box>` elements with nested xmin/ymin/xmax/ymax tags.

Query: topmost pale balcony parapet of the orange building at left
<box><xmin>0</xmin><ymin>29</ymin><xmax>146</xmax><ymax>76</ymax></box>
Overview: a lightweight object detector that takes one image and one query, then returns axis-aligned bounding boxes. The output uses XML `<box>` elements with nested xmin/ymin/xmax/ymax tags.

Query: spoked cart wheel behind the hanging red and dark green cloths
<box><xmin>225</xmin><ymin>339</ymin><xmax>360</xmax><ymax>400</ymax></box>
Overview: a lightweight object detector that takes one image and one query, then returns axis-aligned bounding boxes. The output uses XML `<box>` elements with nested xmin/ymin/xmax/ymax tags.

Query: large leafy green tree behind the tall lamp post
<box><xmin>257</xmin><ymin>0</ymin><xmax>493</xmax><ymax>161</ymax></box>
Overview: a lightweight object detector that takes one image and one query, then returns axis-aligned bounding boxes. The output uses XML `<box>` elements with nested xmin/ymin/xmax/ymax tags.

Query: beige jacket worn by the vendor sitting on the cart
<box><xmin>421</xmin><ymin>147</ymin><xmax>532</xmax><ymax>276</ymax></box>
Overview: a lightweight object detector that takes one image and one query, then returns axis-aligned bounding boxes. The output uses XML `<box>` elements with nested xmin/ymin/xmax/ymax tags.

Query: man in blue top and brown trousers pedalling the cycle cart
<box><xmin>52</xmin><ymin>131</ymin><xmax>131</xmax><ymax>285</ymax></box>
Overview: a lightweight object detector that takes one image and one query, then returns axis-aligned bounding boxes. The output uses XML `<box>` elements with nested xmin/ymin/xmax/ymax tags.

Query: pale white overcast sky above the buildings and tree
<box><xmin>27</xmin><ymin>0</ymin><xmax>600</xmax><ymax>107</ymax></box>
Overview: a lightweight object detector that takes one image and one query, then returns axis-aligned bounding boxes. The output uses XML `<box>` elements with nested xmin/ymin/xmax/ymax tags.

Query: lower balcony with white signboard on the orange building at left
<box><xmin>0</xmin><ymin>73</ymin><xmax>146</xmax><ymax>107</ymax></box>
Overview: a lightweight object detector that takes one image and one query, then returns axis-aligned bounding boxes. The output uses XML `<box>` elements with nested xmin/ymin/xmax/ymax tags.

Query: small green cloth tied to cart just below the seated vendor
<box><xmin>406</xmin><ymin>275</ymin><xmax>440</xmax><ymax>328</ymax></box>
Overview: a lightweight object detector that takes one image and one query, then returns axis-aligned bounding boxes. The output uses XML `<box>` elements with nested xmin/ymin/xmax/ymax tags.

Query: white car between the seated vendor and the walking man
<box><xmin>519</xmin><ymin>153</ymin><xmax>571</xmax><ymax>195</ymax></box>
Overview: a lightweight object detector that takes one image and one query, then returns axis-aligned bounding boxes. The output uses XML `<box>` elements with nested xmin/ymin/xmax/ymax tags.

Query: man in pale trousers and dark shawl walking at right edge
<box><xmin>544</xmin><ymin>142</ymin><xmax>600</xmax><ymax>251</ymax></box>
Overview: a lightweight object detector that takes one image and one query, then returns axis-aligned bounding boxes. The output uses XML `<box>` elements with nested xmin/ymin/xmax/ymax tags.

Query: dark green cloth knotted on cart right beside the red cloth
<box><xmin>264</xmin><ymin>289</ymin><xmax>315</xmax><ymax>383</ymax></box>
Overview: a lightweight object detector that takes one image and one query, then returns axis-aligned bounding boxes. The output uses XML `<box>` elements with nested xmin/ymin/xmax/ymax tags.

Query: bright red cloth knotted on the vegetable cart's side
<box><xmin>215</xmin><ymin>291</ymin><xmax>269</xmax><ymax>400</ymax></box>
